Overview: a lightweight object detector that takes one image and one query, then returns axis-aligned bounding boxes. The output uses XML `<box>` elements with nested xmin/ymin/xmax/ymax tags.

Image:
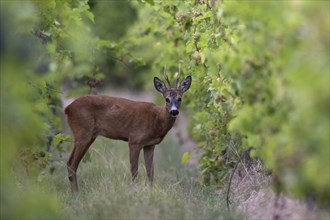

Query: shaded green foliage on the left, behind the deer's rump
<box><xmin>1</xmin><ymin>0</ymin><xmax>141</xmax><ymax>219</ymax></box>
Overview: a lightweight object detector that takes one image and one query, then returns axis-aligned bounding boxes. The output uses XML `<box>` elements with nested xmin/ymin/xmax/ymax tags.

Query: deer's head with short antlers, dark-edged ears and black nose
<box><xmin>154</xmin><ymin>66</ymin><xmax>191</xmax><ymax>117</ymax></box>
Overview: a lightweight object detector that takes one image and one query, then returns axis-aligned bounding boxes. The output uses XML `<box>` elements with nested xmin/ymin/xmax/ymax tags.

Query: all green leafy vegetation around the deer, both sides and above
<box><xmin>0</xmin><ymin>0</ymin><xmax>330</xmax><ymax>219</ymax></box>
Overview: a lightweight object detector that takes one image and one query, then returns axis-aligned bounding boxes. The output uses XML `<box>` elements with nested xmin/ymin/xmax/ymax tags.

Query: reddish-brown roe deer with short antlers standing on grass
<box><xmin>65</xmin><ymin>67</ymin><xmax>191</xmax><ymax>192</ymax></box>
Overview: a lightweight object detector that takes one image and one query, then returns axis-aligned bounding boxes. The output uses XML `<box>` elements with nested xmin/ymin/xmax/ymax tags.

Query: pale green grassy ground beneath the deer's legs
<box><xmin>52</xmin><ymin>137</ymin><xmax>238</xmax><ymax>219</ymax></box>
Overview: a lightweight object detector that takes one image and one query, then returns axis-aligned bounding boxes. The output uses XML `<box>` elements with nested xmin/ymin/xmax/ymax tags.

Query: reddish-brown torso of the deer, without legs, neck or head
<box><xmin>65</xmin><ymin>95</ymin><xmax>160</xmax><ymax>141</ymax></box>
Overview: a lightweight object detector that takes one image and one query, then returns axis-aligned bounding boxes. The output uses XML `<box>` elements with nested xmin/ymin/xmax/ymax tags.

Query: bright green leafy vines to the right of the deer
<box><xmin>125</xmin><ymin>1</ymin><xmax>329</xmax><ymax>204</ymax></box>
